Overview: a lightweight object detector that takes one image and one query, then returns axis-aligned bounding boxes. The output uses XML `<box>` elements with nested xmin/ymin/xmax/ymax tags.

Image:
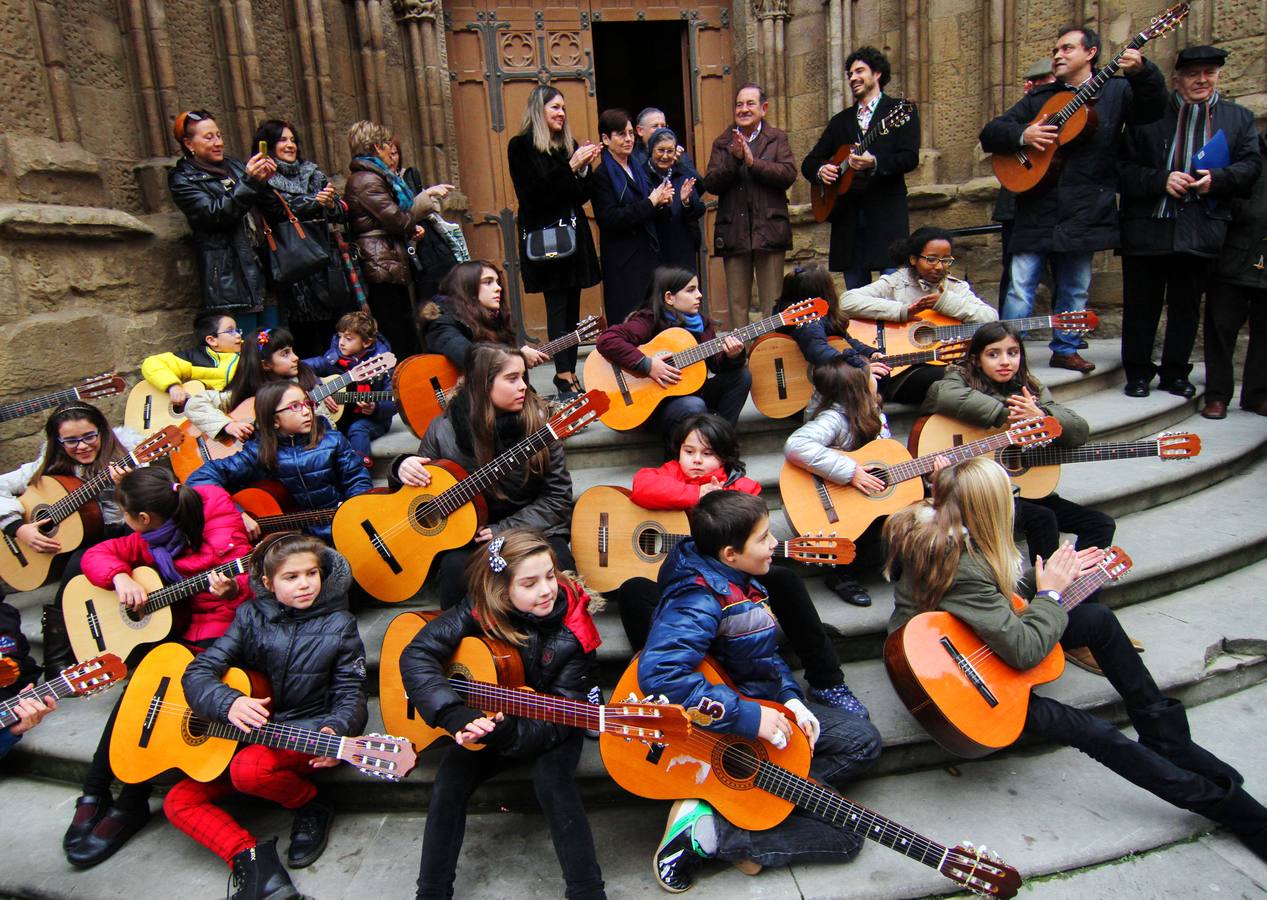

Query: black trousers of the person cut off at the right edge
<box><xmin>1205</xmin><ymin>279</ymin><xmax>1267</xmax><ymax>409</ymax></box>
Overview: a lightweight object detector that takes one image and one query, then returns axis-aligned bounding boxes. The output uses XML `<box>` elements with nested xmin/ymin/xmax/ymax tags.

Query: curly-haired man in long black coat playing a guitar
<box><xmin>801</xmin><ymin>47</ymin><xmax>920</xmax><ymax>288</ymax></box>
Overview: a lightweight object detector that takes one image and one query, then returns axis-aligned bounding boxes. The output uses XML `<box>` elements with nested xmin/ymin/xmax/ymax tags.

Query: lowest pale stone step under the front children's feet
<box><xmin>0</xmin><ymin>686</ymin><xmax>1267</xmax><ymax>900</ymax></box>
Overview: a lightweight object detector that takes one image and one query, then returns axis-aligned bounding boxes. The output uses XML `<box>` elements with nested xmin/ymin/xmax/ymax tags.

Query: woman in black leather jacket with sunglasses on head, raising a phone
<box><xmin>167</xmin><ymin>109</ymin><xmax>277</xmax><ymax>331</ymax></box>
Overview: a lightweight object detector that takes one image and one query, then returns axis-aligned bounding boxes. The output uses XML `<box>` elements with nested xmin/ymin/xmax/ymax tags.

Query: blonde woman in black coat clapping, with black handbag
<box><xmin>506</xmin><ymin>85</ymin><xmax>602</xmax><ymax>394</ymax></box>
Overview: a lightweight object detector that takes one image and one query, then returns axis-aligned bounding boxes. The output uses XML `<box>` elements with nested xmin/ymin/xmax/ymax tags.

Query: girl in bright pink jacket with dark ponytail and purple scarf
<box><xmin>62</xmin><ymin>466</ymin><xmax>251</xmax><ymax>868</ymax></box>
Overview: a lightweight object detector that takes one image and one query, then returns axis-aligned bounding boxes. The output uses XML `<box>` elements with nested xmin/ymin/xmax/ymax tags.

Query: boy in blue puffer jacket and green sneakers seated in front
<box><xmin>637</xmin><ymin>491</ymin><xmax>881</xmax><ymax>894</ymax></box>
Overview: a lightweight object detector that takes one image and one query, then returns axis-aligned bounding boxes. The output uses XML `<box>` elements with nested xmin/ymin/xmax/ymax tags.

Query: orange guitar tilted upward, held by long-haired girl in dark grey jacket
<box><xmin>331</xmin><ymin>390</ymin><xmax>608</xmax><ymax>603</ymax></box>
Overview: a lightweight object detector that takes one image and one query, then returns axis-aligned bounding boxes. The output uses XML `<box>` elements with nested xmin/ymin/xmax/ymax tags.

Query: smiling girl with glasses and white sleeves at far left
<box><xmin>0</xmin><ymin>401</ymin><xmax>141</xmax><ymax>678</ymax></box>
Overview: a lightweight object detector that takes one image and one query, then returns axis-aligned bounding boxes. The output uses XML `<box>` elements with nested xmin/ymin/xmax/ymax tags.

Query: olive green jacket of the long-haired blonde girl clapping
<box><xmin>888</xmin><ymin>551</ymin><xmax>1069</xmax><ymax>669</ymax></box>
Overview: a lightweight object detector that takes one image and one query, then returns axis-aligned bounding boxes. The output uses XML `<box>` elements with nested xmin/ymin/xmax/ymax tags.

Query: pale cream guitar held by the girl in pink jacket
<box><xmin>62</xmin><ymin>553</ymin><xmax>251</xmax><ymax>659</ymax></box>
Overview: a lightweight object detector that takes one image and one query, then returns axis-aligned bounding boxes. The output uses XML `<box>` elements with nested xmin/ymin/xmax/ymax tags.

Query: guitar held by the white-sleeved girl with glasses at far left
<box><xmin>0</xmin><ymin>426</ymin><xmax>184</xmax><ymax>591</ymax></box>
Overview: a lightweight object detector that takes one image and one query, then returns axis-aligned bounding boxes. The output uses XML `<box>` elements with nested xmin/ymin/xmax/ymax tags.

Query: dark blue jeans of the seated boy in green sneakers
<box><xmin>713</xmin><ymin>701</ymin><xmax>881</xmax><ymax>866</ymax></box>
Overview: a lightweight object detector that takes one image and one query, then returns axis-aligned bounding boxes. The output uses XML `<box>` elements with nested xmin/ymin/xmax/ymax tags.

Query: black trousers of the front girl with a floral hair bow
<box><xmin>417</xmin><ymin>731</ymin><xmax>607</xmax><ymax>900</ymax></box>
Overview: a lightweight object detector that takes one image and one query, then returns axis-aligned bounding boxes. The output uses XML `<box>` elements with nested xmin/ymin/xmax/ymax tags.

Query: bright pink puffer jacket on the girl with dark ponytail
<box><xmin>82</xmin><ymin>485</ymin><xmax>252</xmax><ymax>641</ymax></box>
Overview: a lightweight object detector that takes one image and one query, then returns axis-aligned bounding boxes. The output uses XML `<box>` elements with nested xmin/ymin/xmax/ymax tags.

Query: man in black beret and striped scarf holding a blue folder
<box><xmin>1120</xmin><ymin>46</ymin><xmax>1262</xmax><ymax>397</ymax></box>
